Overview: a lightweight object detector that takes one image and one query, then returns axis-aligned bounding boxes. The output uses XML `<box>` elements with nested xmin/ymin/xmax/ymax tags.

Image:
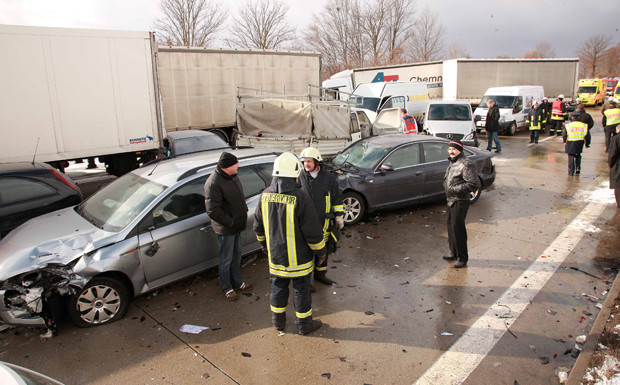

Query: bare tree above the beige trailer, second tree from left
<box><xmin>225</xmin><ymin>0</ymin><xmax>295</xmax><ymax>49</ymax></box>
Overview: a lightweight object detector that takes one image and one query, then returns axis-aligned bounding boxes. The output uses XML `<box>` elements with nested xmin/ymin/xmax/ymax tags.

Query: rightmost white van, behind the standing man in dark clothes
<box><xmin>474</xmin><ymin>86</ymin><xmax>545</xmax><ymax>135</ymax></box>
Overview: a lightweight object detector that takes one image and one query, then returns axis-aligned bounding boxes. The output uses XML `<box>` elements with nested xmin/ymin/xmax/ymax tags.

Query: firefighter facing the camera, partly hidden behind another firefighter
<box><xmin>299</xmin><ymin>147</ymin><xmax>344</xmax><ymax>285</ymax></box>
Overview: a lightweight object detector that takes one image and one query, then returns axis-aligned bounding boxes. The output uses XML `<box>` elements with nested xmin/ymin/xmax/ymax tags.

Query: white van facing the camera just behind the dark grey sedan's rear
<box><xmin>424</xmin><ymin>100</ymin><xmax>479</xmax><ymax>147</ymax></box>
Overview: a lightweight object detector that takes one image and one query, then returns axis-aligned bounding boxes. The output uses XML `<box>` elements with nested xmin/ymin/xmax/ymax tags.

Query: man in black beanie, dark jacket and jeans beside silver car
<box><xmin>205</xmin><ymin>152</ymin><xmax>252</xmax><ymax>301</ymax></box>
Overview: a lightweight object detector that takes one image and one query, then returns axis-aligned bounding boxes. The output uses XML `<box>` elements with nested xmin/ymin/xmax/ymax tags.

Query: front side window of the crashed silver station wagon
<box><xmin>153</xmin><ymin>176</ymin><xmax>208</xmax><ymax>227</ymax></box>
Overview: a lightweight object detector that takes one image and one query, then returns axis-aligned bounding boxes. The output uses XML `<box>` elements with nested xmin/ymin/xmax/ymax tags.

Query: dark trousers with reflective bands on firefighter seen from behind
<box><xmin>269</xmin><ymin>274</ymin><xmax>312</xmax><ymax>325</ymax></box>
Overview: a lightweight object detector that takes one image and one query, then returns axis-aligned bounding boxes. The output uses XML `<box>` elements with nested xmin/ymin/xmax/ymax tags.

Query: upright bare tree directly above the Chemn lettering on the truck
<box><xmin>410</xmin><ymin>5</ymin><xmax>445</xmax><ymax>61</ymax></box>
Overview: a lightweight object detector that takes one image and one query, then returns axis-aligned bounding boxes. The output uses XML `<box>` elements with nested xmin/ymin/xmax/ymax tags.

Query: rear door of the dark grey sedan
<box><xmin>422</xmin><ymin>141</ymin><xmax>449</xmax><ymax>200</ymax></box>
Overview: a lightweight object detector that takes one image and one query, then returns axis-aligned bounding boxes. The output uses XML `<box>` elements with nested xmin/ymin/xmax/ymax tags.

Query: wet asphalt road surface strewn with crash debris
<box><xmin>0</xmin><ymin>109</ymin><xmax>620</xmax><ymax>385</ymax></box>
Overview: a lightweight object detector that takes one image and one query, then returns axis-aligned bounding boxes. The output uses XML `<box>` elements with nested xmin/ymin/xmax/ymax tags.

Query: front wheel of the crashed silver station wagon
<box><xmin>67</xmin><ymin>277</ymin><xmax>131</xmax><ymax>328</ymax></box>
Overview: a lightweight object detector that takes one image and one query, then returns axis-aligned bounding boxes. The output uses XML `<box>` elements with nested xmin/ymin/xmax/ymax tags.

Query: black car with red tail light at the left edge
<box><xmin>0</xmin><ymin>162</ymin><xmax>82</xmax><ymax>238</ymax></box>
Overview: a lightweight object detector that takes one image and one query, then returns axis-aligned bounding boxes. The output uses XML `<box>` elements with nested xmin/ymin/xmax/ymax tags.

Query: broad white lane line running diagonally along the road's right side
<box><xmin>414</xmin><ymin>190</ymin><xmax>611</xmax><ymax>385</ymax></box>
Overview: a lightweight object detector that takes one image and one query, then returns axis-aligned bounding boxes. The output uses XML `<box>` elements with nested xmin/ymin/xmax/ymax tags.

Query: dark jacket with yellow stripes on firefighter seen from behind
<box><xmin>254</xmin><ymin>178</ymin><xmax>325</xmax><ymax>278</ymax></box>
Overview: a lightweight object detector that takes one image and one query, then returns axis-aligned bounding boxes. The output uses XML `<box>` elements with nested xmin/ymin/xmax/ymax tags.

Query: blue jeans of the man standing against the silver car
<box><xmin>217</xmin><ymin>232</ymin><xmax>243</xmax><ymax>293</ymax></box>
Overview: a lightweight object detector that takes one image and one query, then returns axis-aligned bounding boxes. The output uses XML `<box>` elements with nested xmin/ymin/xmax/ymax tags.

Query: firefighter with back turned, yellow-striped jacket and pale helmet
<box><xmin>254</xmin><ymin>152</ymin><xmax>326</xmax><ymax>334</ymax></box>
